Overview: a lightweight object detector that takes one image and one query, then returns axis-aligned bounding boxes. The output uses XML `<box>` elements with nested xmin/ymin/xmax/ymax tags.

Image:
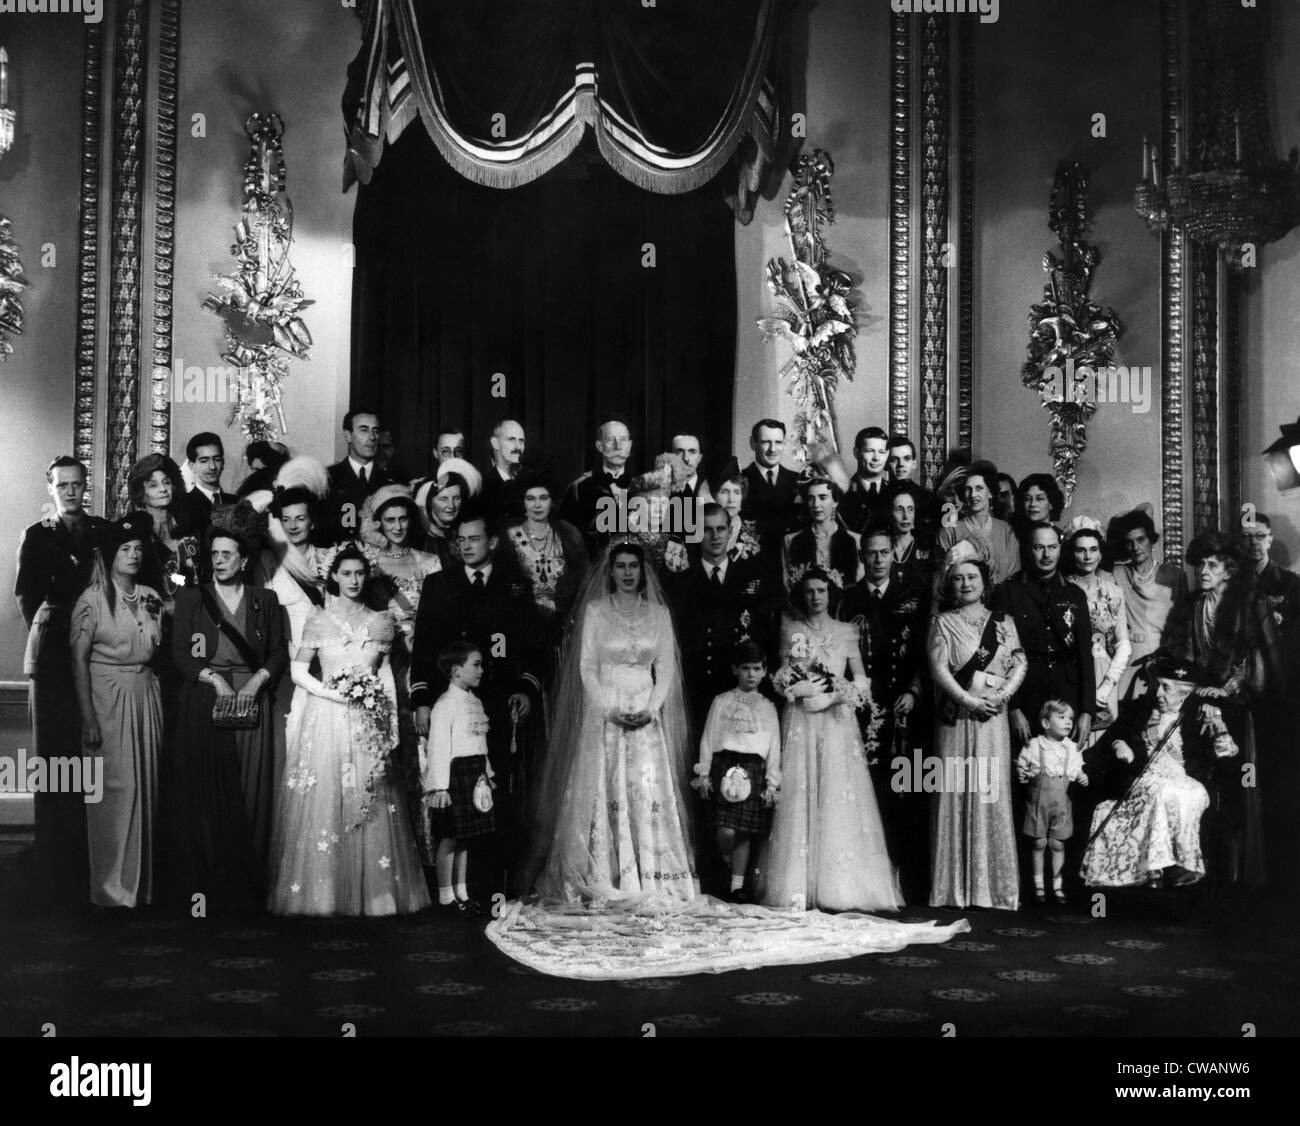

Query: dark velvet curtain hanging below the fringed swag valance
<box><xmin>352</xmin><ymin>129</ymin><xmax>736</xmax><ymax>488</ymax></box>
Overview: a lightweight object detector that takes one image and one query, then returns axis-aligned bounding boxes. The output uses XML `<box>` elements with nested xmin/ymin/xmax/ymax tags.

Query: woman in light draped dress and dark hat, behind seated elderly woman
<box><xmin>1108</xmin><ymin>508</ymin><xmax>1187</xmax><ymax>701</ymax></box>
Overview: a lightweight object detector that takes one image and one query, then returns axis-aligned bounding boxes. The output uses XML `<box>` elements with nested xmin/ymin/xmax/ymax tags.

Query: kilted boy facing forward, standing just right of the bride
<box><xmin>696</xmin><ymin>638</ymin><xmax>781</xmax><ymax>904</ymax></box>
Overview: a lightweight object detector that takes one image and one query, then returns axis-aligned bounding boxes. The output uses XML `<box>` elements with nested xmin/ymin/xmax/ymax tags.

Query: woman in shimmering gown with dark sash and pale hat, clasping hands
<box><xmin>928</xmin><ymin>541</ymin><xmax>1028</xmax><ymax>911</ymax></box>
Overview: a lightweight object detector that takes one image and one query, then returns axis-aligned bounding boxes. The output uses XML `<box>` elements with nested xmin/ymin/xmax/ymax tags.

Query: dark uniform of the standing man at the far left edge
<box><xmin>13</xmin><ymin>516</ymin><xmax>107</xmax><ymax>902</ymax></box>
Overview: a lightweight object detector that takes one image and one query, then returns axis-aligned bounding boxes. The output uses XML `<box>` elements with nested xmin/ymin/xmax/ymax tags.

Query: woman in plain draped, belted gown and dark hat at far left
<box><xmin>70</xmin><ymin>512</ymin><xmax>163</xmax><ymax>908</ymax></box>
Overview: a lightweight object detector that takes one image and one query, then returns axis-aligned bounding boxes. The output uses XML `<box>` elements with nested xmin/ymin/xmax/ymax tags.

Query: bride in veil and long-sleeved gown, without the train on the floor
<box><xmin>537</xmin><ymin>542</ymin><xmax>699</xmax><ymax>902</ymax></box>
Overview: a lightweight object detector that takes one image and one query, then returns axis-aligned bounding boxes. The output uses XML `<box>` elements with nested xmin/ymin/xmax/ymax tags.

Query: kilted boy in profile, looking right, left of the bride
<box><xmin>424</xmin><ymin>641</ymin><xmax>497</xmax><ymax>915</ymax></box>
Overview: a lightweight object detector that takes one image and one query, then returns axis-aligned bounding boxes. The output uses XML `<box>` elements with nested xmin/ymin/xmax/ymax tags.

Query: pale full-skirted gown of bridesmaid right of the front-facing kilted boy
<box><xmin>758</xmin><ymin>618</ymin><xmax>902</xmax><ymax>911</ymax></box>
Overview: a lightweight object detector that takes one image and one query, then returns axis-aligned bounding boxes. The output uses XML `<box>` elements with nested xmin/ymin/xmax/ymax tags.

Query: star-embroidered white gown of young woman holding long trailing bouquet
<box><xmin>270</xmin><ymin>610</ymin><xmax>429</xmax><ymax>915</ymax></box>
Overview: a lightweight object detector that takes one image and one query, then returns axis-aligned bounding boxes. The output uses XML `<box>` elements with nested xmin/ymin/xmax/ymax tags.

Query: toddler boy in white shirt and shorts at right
<box><xmin>1015</xmin><ymin>700</ymin><xmax>1088</xmax><ymax>904</ymax></box>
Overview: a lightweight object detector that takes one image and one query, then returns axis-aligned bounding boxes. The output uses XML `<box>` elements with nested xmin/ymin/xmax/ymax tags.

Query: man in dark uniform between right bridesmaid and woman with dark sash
<box><xmin>840</xmin><ymin>529</ymin><xmax>930</xmax><ymax>900</ymax></box>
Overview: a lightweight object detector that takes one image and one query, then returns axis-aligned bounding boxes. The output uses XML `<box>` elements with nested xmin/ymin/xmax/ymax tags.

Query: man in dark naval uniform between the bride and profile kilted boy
<box><xmin>411</xmin><ymin>511</ymin><xmax>542</xmax><ymax>896</ymax></box>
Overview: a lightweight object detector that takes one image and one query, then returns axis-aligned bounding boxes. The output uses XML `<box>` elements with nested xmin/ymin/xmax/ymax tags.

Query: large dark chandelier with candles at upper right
<box><xmin>1134</xmin><ymin>0</ymin><xmax>1300</xmax><ymax>269</ymax></box>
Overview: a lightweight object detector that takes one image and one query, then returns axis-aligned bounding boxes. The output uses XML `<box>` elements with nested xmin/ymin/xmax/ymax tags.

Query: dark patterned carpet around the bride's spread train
<box><xmin>0</xmin><ymin>835</ymin><xmax>1300</xmax><ymax>1038</ymax></box>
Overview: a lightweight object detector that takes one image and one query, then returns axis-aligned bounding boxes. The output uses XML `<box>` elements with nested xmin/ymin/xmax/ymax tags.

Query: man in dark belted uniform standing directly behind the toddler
<box><xmin>989</xmin><ymin>521</ymin><xmax>1097</xmax><ymax>889</ymax></box>
